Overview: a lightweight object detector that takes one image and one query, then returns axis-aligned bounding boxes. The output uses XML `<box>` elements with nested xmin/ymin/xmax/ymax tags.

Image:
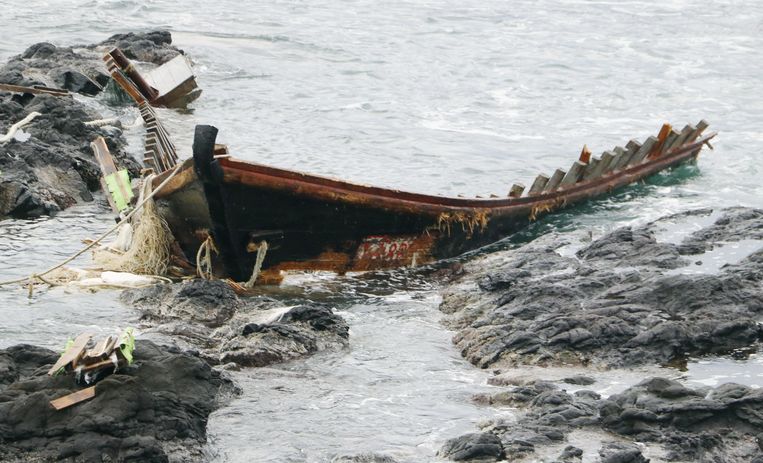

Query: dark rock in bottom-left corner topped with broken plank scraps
<box><xmin>0</xmin><ymin>340</ymin><xmax>236</xmax><ymax>462</ymax></box>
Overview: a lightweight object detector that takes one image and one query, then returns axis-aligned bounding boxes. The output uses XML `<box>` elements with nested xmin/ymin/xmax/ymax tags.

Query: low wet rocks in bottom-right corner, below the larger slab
<box><xmin>440</xmin><ymin>377</ymin><xmax>763</xmax><ymax>463</ymax></box>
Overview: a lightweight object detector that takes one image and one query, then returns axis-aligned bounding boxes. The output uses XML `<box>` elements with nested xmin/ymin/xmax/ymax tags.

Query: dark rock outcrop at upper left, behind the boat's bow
<box><xmin>0</xmin><ymin>32</ymin><xmax>180</xmax><ymax>218</ymax></box>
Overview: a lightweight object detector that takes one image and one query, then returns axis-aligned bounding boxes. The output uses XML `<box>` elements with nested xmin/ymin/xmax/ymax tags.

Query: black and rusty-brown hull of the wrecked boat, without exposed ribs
<box><xmin>157</xmin><ymin>126</ymin><xmax>712</xmax><ymax>281</ymax></box>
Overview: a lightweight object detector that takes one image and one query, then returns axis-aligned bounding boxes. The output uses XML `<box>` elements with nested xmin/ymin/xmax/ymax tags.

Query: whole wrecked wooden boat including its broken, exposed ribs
<box><xmin>97</xmin><ymin>52</ymin><xmax>715</xmax><ymax>282</ymax></box>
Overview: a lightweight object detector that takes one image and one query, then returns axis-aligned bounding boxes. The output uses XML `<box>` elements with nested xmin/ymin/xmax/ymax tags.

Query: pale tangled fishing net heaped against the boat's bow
<box><xmin>93</xmin><ymin>175</ymin><xmax>173</xmax><ymax>275</ymax></box>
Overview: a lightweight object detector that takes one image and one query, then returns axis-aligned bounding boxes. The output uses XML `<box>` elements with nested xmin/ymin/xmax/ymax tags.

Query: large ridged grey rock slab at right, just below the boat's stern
<box><xmin>441</xmin><ymin>208</ymin><xmax>763</xmax><ymax>368</ymax></box>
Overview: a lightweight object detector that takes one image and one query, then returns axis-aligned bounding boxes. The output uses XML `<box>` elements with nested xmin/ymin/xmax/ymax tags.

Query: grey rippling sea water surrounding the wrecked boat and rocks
<box><xmin>0</xmin><ymin>0</ymin><xmax>763</xmax><ymax>462</ymax></box>
